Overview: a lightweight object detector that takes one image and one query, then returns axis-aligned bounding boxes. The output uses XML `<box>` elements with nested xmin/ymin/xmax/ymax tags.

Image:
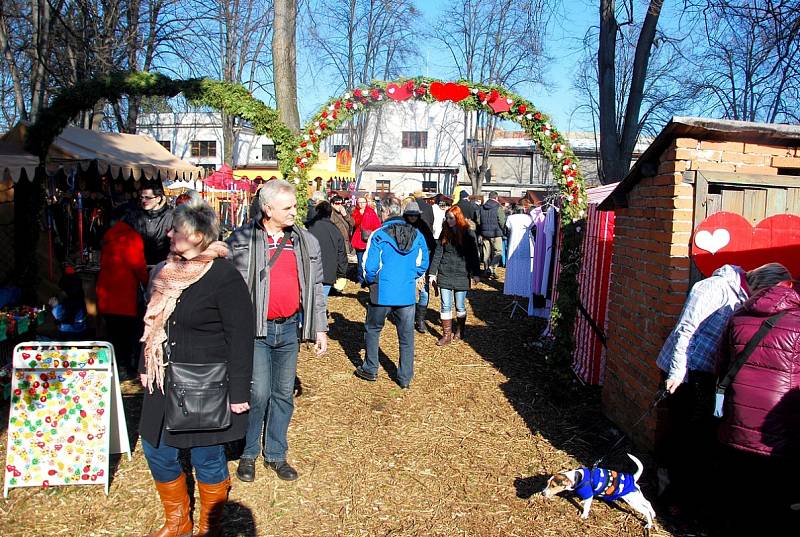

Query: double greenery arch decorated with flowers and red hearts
<box><xmin>27</xmin><ymin>72</ymin><xmax>587</xmax><ymax>363</ymax></box>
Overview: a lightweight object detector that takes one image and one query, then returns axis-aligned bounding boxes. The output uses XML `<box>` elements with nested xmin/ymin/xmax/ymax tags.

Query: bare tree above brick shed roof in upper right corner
<box><xmin>692</xmin><ymin>0</ymin><xmax>800</xmax><ymax>123</ymax></box>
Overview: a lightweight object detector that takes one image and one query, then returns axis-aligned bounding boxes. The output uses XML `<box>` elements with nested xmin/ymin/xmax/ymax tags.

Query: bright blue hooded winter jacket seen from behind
<box><xmin>364</xmin><ymin>216</ymin><xmax>429</xmax><ymax>306</ymax></box>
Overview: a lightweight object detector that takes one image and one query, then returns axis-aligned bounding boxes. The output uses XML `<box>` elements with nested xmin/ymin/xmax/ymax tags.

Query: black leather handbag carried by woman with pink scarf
<box><xmin>164</xmin><ymin>362</ymin><xmax>231</xmax><ymax>433</ymax></box>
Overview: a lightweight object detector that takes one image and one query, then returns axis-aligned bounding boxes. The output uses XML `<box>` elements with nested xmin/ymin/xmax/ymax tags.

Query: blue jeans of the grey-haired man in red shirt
<box><xmin>242</xmin><ymin>315</ymin><xmax>300</xmax><ymax>462</ymax></box>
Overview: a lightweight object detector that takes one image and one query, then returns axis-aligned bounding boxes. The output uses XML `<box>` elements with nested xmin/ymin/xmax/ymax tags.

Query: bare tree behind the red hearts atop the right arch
<box><xmin>431</xmin><ymin>0</ymin><xmax>555</xmax><ymax>194</ymax></box>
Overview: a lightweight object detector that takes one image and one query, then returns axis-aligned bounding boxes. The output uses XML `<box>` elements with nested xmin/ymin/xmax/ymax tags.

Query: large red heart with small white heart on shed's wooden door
<box><xmin>692</xmin><ymin>212</ymin><xmax>800</xmax><ymax>278</ymax></box>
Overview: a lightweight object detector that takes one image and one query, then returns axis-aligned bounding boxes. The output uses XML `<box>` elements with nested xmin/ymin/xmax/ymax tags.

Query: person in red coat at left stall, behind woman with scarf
<box><xmin>96</xmin><ymin>208</ymin><xmax>148</xmax><ymax>376</ymax></box>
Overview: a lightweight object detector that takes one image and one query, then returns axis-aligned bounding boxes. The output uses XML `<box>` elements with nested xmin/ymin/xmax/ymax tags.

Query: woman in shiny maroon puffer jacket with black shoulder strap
<box><xmin>718</xmin><ymin>281</ymin><xmax>800</xmax><ymax>531</ymax></box>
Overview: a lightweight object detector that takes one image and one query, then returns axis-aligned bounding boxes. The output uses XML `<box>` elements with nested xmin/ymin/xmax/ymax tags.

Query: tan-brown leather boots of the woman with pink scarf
<box><xmin>147</xmin><ymin>474</ymin><xmax>231</xmax><ymax>537</ymax></box>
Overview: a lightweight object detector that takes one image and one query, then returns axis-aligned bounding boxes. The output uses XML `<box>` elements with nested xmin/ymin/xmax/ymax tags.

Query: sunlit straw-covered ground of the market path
<box><xmin>0</xmin><ymin>272</ymin><xmax>671</xmax><ymax>537</ymax></box>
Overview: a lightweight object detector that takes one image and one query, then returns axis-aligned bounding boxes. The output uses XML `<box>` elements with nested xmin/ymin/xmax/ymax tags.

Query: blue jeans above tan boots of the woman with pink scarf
<box><xmin>142</xmin><ymin>438</ymin><xmax>229</xmax><ymax>485</ymax></box>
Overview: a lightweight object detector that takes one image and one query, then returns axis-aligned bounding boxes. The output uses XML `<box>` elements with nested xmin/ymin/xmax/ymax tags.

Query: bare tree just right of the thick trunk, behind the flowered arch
<box><xmin>305</xmin><ymin>0</ymin><xmax>419</xmax><ymax>182</ymax></box>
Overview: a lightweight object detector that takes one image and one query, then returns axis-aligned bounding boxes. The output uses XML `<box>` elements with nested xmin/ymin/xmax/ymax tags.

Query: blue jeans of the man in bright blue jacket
<box><xmin>361</xmin><ymin>304</ymin><xmax>414</xmax><ymax>385</ymax></box>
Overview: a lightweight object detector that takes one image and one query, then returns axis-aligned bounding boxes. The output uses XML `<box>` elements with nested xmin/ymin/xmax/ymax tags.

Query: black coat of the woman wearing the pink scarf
<box><xmin>139</xmin><ymin>259</ymin><xmax>255</xmax><ymax>448</ymax></box>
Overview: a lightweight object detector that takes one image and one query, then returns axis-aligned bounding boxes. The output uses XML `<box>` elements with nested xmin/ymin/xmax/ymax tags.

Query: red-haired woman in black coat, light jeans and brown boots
<box><xmin>428</xmin><ymin>205</ymin><xmax>480</xmax><ymax>346</ymax></box>
